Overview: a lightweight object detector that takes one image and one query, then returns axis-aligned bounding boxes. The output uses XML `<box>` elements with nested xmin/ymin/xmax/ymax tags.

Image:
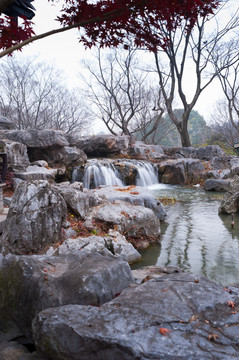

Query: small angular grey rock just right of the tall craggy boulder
<box><xmin>55</xmin><ymin>182</ymin><xmax>100</xmax><ymax>219</ymax></box>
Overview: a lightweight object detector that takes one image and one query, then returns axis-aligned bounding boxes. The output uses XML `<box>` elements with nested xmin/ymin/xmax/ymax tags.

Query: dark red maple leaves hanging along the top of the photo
<box><xmin>0</xmin><ymin>0</ymin><xmax>221</xmax><ymax>50</ymax></box>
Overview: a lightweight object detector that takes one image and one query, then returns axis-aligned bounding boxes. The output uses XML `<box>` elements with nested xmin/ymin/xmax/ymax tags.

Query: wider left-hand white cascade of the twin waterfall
<box><xmin>83</xmin><ymin>162</ymin><xmax>124</xmax><ymax>189</ymax></box>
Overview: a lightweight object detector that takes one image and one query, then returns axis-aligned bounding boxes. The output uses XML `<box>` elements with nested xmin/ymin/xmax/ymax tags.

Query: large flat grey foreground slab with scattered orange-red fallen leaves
<box><xmin>33</xmin><ymin>273</ymin><xmax>239</xmax><ymax>360</ymax></box>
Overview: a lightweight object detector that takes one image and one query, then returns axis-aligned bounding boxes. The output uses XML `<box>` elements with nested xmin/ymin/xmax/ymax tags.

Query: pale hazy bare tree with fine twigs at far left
<box><xmin>0</xmin><ymin>58</ymin><xmax>90</xmax><ymax>133</ymax></box>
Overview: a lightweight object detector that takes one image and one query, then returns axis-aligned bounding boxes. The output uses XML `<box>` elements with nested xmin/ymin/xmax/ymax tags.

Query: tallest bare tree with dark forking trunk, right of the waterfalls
<box><xmin>150</xmin><ymin>2</ymin><xmax>239</xmax><ymax>146</ymax></box>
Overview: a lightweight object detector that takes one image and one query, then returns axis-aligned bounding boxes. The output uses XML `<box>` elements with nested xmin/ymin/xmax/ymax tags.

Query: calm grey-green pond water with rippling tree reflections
<box><xmin>134</xmin><ymin>184</ymin><xmax>239</xmax><ymax>285</ymax></box>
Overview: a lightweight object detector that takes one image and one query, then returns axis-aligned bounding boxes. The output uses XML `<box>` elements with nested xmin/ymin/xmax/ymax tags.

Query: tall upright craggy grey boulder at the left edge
<box><xmin>2</xmin><ymin>180</ymin><xmax>66</xmax><ymax>254</ymax></box>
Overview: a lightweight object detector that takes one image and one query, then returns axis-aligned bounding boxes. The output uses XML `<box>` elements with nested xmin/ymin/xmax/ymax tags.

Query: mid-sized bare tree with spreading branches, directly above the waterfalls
<box><xmin>81</xmin><ymin>49</ymin><xmax>164</xmax><ymax>141</ymax></box>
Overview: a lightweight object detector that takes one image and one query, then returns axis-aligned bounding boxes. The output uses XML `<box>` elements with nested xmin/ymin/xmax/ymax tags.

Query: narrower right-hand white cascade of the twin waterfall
<box><xmin>136</xmin><ymin>162</ymin><xmax>158</xmax><ymax>187</ymax></box>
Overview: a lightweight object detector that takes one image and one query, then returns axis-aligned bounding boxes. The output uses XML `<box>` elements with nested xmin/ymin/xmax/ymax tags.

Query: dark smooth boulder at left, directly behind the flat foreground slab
<box><xmin>0</xmin><ymin>251</ymin><xmax>133</xmax><ymax>338</ymax></box>
